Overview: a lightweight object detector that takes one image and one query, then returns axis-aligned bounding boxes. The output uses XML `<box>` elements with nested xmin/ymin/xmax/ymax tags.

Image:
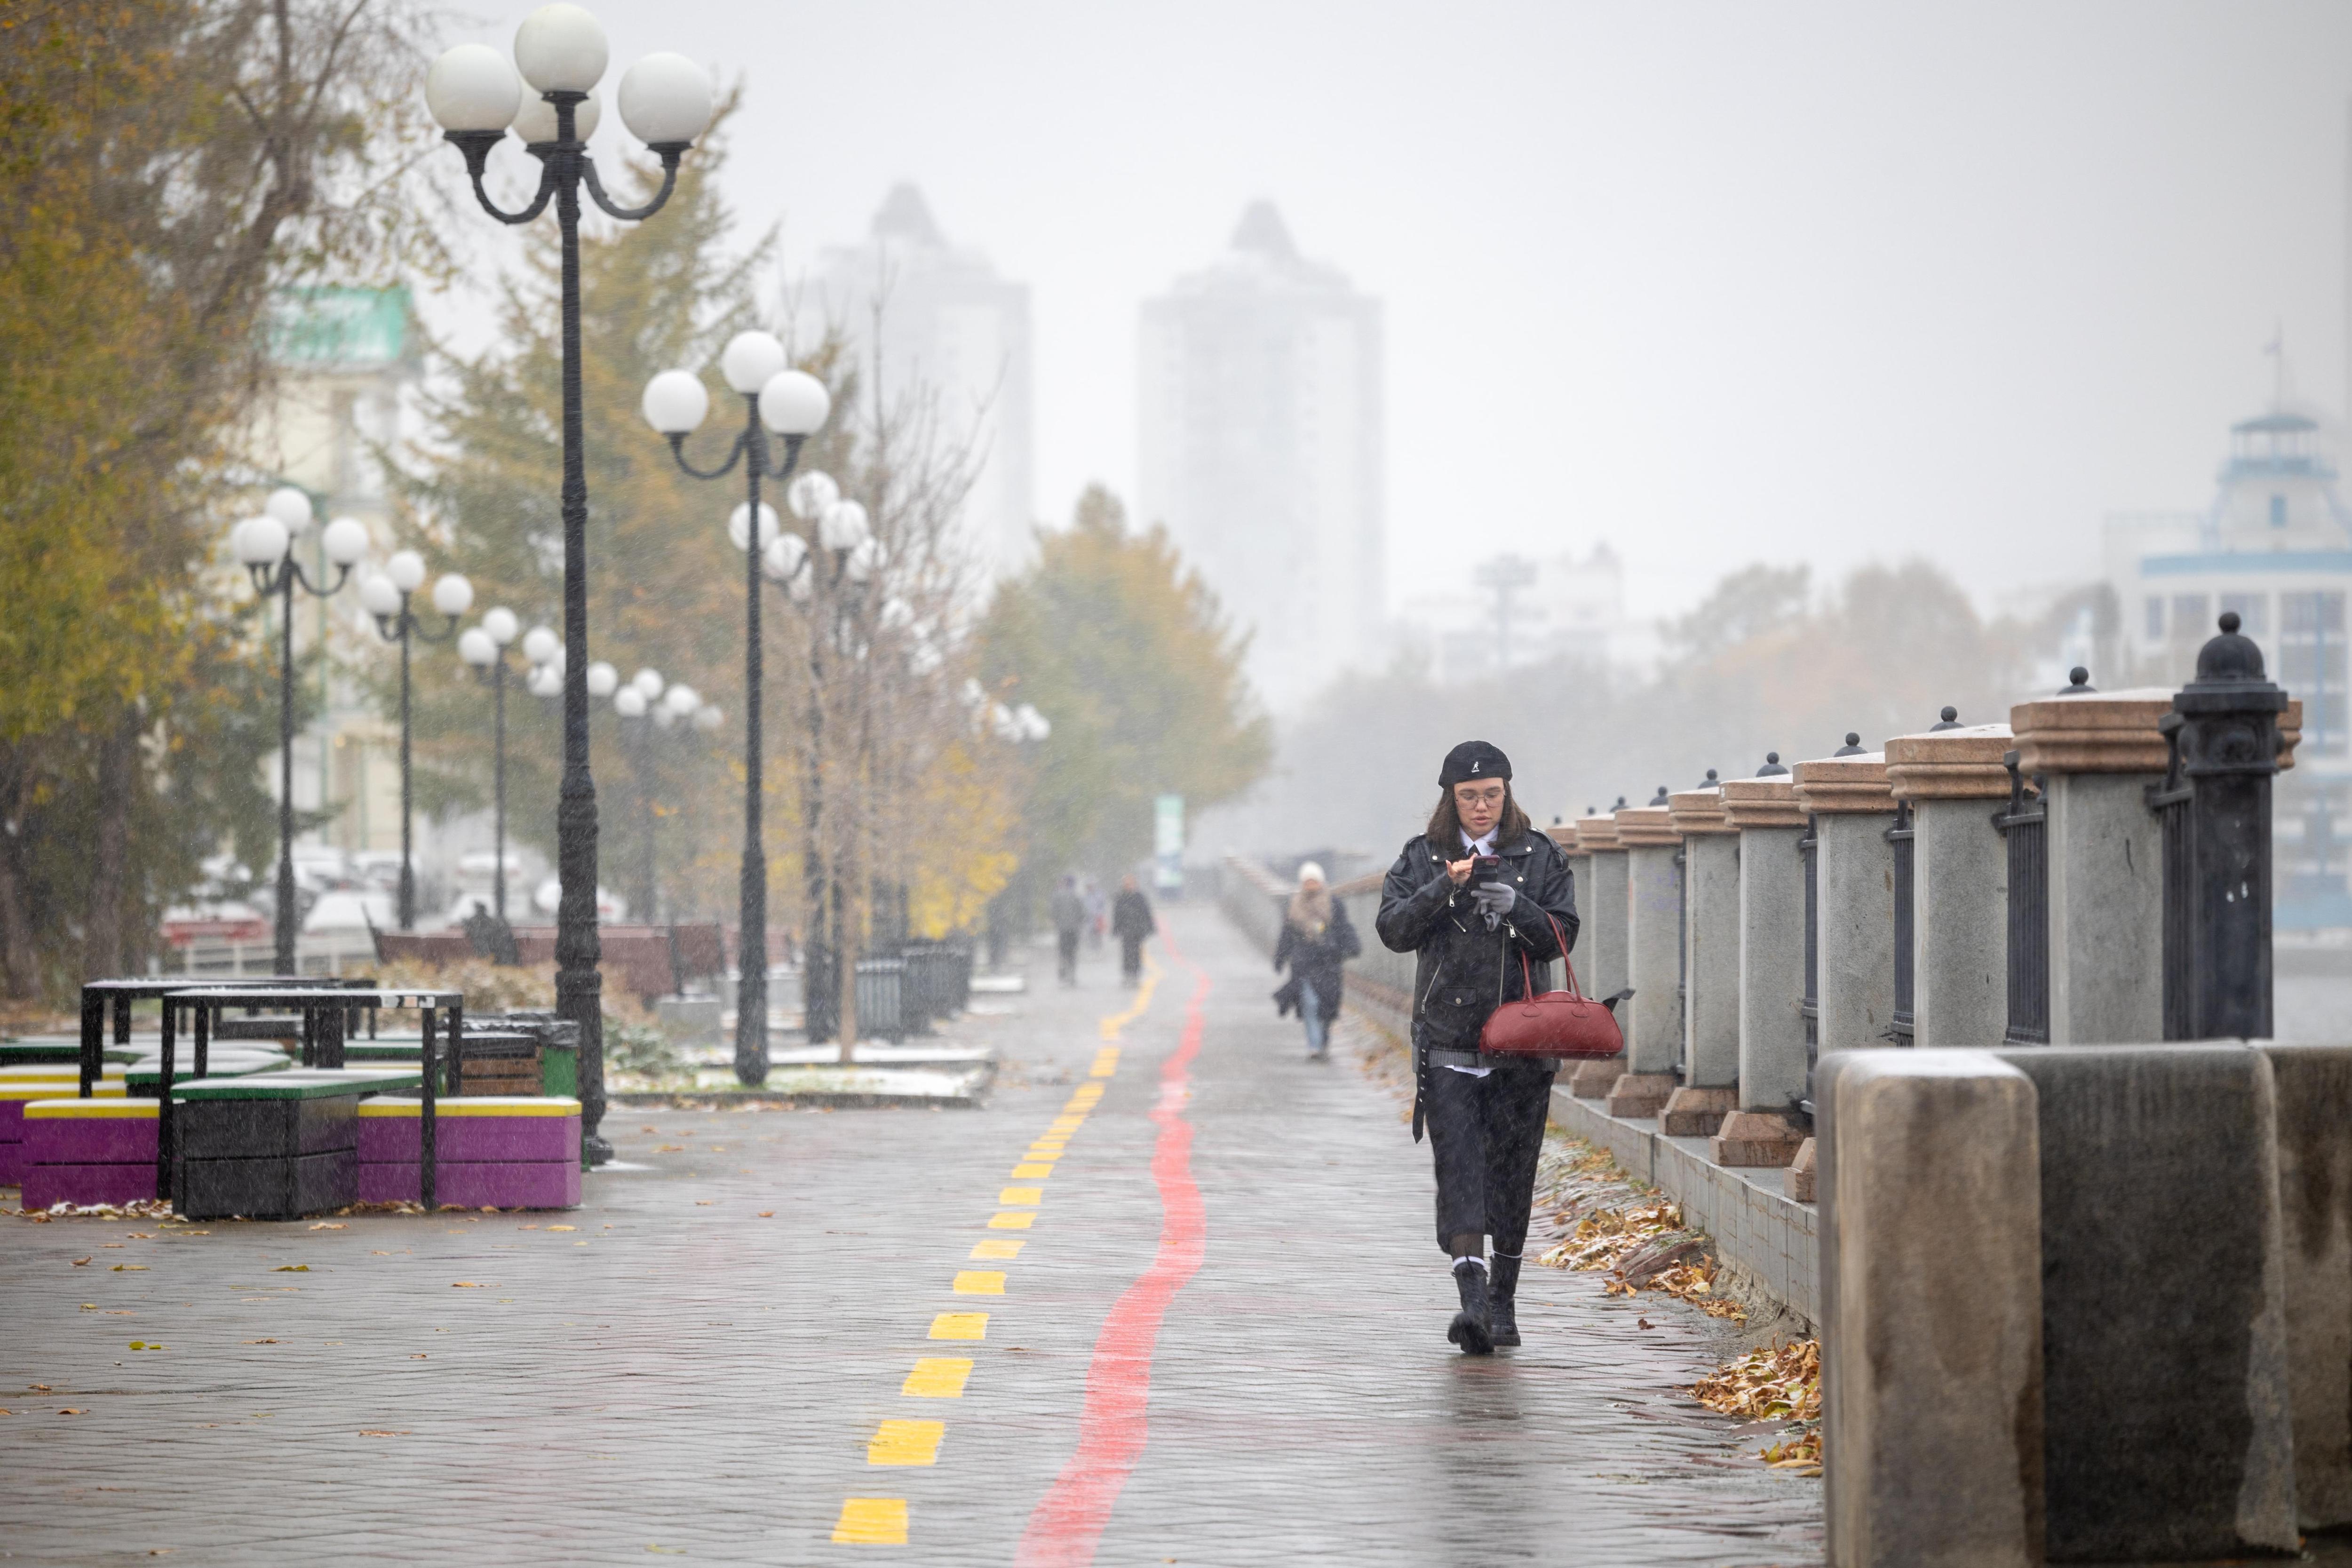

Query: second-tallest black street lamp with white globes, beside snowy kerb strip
<box><xmin>644</xmin><ymin>332</ymin><xmax>833</xmax><ymax>1089</ymax></box>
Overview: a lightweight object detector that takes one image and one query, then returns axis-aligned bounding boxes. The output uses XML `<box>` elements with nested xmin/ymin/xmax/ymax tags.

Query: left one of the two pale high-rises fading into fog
<box><xmin>795</xmin><ymin>183</ymin><xmax>1035</xmax><ymax>573</ymax></box>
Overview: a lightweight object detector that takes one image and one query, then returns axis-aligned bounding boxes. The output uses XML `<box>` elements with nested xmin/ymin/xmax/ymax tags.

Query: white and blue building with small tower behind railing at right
<box><xmin>2105</xmin><ymin>402</ymin><xmax>2352</xmax><ymax>933</ymax></box>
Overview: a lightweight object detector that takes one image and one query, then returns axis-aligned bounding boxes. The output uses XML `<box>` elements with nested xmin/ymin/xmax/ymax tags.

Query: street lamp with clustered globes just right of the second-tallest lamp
<box><xmin>764</xmin><ymin>472</ymin><xmax>877</xmax><ymax>1060</ymax></box>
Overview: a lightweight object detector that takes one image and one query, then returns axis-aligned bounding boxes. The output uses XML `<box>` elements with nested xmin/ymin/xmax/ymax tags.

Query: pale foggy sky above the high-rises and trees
<box><xmin>423</xmin><ymin>0</ymin><xmax>2352</xmax><ymax>613</ymax></box>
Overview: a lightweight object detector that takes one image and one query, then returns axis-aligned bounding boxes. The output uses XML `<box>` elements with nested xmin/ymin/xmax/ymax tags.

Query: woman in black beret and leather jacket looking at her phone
<box><xmin>1376</xmin><ymin>740</ymin><xmax>1576</xmax><ymax>1356</ymax></box>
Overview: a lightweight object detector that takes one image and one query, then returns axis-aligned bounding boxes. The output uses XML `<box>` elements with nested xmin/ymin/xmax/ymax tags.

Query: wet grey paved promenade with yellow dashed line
<box><xmin>0</xmin><ymin>907</ymin><xmax>1820</xmax><ymax>1568</ymax></box>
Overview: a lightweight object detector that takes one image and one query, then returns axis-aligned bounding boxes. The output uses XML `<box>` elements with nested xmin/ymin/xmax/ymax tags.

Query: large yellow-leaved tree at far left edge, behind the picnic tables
<box><xmin>0</xmin><ymin>0</ymin><xmax>437</xmax><ymax>997</ymax></box>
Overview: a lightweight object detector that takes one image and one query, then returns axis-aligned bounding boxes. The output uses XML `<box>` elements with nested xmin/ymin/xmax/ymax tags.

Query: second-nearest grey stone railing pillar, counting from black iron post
<box><xmin>1886</xmin><ymin>724</ymin><xmax>2016</xmax><ymax>1046</ymax></box>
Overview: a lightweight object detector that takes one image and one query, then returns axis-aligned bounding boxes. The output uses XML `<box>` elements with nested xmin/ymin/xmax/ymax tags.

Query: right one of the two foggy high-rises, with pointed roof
<box><xmin>1138</xmin><ymin>202</ymin><xmax>1388</xmax><ymax>710</ymax></box>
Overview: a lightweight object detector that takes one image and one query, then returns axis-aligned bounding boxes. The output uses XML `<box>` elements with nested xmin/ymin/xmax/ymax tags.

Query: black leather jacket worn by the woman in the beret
<box><xmin>1374</xmin><ymin>828</ymin><xmax>1576</xmax><ymax>1067</ymax></box>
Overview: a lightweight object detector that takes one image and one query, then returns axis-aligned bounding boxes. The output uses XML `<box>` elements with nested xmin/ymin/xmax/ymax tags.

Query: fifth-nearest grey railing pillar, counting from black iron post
<box><xmin>1658</xmin><ymin>785</ymin><xmax>1740</xmax><ymax>1138</ymax></box>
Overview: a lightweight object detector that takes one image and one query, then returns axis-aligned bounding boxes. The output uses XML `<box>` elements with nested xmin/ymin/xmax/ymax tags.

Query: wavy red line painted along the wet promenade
<box><xmin>1014</xmin><ymin>931</ymin><xmax>1209</xmax><ymax>1568</ymax></box>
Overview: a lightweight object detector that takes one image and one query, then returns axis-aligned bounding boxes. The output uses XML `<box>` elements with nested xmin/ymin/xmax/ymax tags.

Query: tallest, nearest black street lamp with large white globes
<box><xmin>426</xmin><ymin>5</ymin><xmax>713</xmax><ymax>1164</ymax></box>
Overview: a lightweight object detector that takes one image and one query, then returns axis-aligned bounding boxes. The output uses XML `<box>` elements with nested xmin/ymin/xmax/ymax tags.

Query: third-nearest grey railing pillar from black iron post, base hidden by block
<box><xmin>1797</xmin><ymin>736</ymin><xmax>1896</xmax><ymax>1056</ymax></box>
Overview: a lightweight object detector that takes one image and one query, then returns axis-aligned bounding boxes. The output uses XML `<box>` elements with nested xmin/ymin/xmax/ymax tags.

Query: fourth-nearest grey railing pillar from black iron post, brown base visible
<box><xmin>1710</xmin><ymin>757</ymin><xmax>1804</xmax><ymax>1166</ymax></box>
